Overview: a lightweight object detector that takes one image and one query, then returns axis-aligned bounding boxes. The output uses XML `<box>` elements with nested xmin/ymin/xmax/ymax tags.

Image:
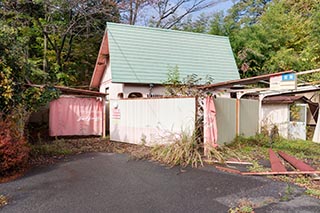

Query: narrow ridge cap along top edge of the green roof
<box><xmin>106</xmin><ymin>22</ymin><xmax>229</xmax><ymax>40</ymax></box>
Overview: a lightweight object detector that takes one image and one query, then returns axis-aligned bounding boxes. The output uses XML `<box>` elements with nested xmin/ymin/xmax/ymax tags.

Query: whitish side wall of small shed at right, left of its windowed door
<box><xmin>262</xmin><ymin>104</ymin><xmax>290</xmax><ymax>138</ymax></box>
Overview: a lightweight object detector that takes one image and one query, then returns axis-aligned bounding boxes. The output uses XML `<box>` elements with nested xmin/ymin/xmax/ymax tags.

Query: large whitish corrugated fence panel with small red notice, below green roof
<box><xmin>110</xmin><ymin>98</ymin><xmax>196</xmax><ymax>145</ymax></box>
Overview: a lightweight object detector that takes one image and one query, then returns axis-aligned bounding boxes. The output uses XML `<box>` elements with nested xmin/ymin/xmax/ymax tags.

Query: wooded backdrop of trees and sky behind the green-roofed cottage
<box><xmin>0</xmin><ymin>0</ymin><xmax>320</xmax><ymax>117</ymax></box>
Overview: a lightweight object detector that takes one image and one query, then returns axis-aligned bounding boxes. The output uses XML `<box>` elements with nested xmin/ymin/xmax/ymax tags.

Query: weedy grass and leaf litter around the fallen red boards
<box><xmin>232</xmin><ymin>134</ymin><xmax>320</xmax><ymax>199</ymax></box>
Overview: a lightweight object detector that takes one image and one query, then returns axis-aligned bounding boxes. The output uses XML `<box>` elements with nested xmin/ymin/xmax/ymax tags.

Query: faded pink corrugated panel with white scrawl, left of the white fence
<box><xmin>49</xmin><ymin>97</ymin><xmax>103</xmax><ymax>136</ymax></box>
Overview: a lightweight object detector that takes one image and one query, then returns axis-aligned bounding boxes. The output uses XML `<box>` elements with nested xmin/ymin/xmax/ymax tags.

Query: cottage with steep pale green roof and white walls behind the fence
<box><xmin>90</xmin><ymin>23</ymin><xmax>239</xmax><ymax>99</ymax></box>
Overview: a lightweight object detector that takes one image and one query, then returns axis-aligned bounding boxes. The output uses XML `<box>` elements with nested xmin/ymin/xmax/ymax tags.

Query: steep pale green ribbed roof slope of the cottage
<box><xmin>107</xmin><ymin>23</ymin><xmax>239</xmax><ymax>84</ymax></box>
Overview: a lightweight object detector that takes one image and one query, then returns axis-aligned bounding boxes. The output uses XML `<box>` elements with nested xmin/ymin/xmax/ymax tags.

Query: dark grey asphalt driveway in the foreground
<box><xmin>0</xmin><ymin>153</ymin><xmax>320</xmax><ymax>213</ymax></box>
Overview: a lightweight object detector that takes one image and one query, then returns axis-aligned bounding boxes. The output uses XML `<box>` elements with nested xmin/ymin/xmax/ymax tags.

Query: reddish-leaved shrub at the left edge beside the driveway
<box><xmin>0</xmin><ymin>115</ymin><xmax>29</xmax><ymax>176</ymax></box>
